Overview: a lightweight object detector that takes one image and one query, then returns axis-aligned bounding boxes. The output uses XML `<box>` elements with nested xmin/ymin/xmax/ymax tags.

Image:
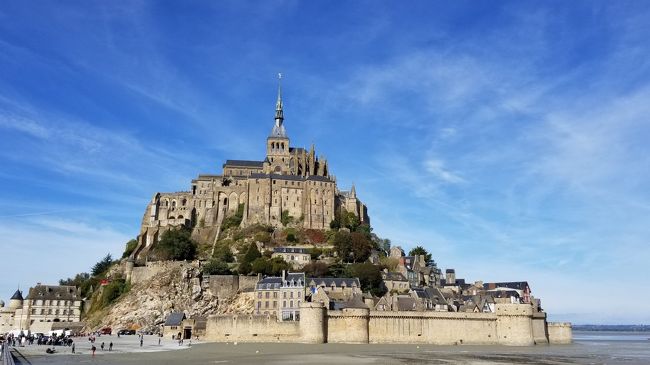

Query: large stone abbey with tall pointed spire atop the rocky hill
<box><xmin>135</xmin><ymin>81</ymin><xmax>369</xmax><ymax>256</ymax></box>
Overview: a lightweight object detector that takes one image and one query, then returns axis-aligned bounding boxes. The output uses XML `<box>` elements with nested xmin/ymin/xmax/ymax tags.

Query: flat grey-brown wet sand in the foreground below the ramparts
<box><xmin>10</xmin><ymin>343</ymin><xmax>648</xmax><ymax>365</ymax></box>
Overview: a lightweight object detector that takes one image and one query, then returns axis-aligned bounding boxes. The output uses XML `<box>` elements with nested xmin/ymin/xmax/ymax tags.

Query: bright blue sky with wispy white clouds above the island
<box><xmin>0</xmin><ymin>1</ymin><xmax>650</xmax><ymax>323</ymax></box>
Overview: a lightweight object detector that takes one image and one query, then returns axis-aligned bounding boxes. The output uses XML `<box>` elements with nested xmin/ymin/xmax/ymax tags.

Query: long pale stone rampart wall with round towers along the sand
<box><xmin>206</xmin><ymin>303</ymin><xmax>571</xmax><ymax>346</ymax></box>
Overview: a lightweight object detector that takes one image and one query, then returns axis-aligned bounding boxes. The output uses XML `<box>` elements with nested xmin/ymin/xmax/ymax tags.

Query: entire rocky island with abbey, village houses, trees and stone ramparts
<box><xmin>0</xmin><ymin>82</ymin><xmax>572</xmax><ymax>352</ymax></box>
